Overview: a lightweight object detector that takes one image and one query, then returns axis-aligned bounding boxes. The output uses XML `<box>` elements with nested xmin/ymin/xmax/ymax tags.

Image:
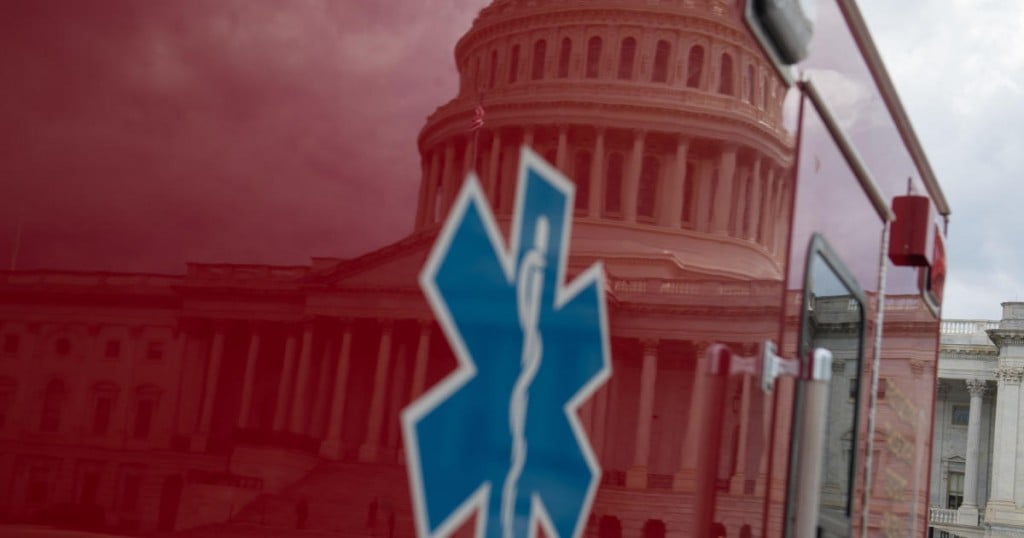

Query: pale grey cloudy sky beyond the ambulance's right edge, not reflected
<box><xmin>861</xmin><ymin>0</ymin><xmax>1024</xmax><ymax>319</ymax></box>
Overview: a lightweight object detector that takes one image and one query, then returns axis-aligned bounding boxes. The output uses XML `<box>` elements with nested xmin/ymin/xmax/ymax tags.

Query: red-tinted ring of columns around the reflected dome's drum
<box><xmin>416</xmin><ymin>124</ymin><xmax>791</xmax><ymax>252</ymax></box>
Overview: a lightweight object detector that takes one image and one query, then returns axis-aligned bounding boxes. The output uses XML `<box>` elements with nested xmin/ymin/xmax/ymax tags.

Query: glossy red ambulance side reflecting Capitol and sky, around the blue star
<box><xmin>0</xmin><ymin>0</ymin><xmax>934</xmax><ymax>538</ymax></box>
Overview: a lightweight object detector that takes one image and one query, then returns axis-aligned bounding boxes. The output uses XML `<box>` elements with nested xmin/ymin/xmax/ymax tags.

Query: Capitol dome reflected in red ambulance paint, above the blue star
<box><xmin>417</xmin><ymin>0</ymin><xmax>794</xmax><ymax>278</ymax></box>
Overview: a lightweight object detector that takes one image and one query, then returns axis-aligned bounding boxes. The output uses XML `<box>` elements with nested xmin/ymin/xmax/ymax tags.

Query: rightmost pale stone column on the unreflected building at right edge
<box><xmin>985</xmin><ymin>364</ymin><xmax>1024</xmax><ymax>523</ymax></box>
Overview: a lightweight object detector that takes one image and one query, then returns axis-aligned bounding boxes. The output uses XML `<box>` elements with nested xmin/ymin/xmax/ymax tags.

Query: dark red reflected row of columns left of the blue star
<box><xmin>194</xmin><ymin>320</ymin><xmax>434</xmax><ymax>461</ymax></box>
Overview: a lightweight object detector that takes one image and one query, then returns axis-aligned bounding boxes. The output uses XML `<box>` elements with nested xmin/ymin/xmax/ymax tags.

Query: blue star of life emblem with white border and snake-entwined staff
<box><xmin>402</xmin><ymin>148</ymin><xmax>611</xmax><ymax>538</ymax></box>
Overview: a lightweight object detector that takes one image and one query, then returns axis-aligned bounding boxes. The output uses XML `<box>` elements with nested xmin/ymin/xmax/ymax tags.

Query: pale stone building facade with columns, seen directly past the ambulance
<box><xmin>930</xmin><ymin>302</ymin><xmax>1024</xmax><ymax>537</ymax></box>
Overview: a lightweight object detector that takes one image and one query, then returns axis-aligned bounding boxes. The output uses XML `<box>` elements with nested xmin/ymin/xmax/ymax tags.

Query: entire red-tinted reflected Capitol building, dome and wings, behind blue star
<box><xmin>0</xmin><ymin>0</ymin><xmax>799</xmax><ymax>537</ymax></box>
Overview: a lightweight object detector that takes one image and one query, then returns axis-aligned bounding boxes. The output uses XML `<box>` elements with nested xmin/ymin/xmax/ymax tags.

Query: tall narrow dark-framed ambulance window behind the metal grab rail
<box><xmin>787</xmin><ymin>236</ymin><xmax>865</xmax><ymax>537</ymax></box>
